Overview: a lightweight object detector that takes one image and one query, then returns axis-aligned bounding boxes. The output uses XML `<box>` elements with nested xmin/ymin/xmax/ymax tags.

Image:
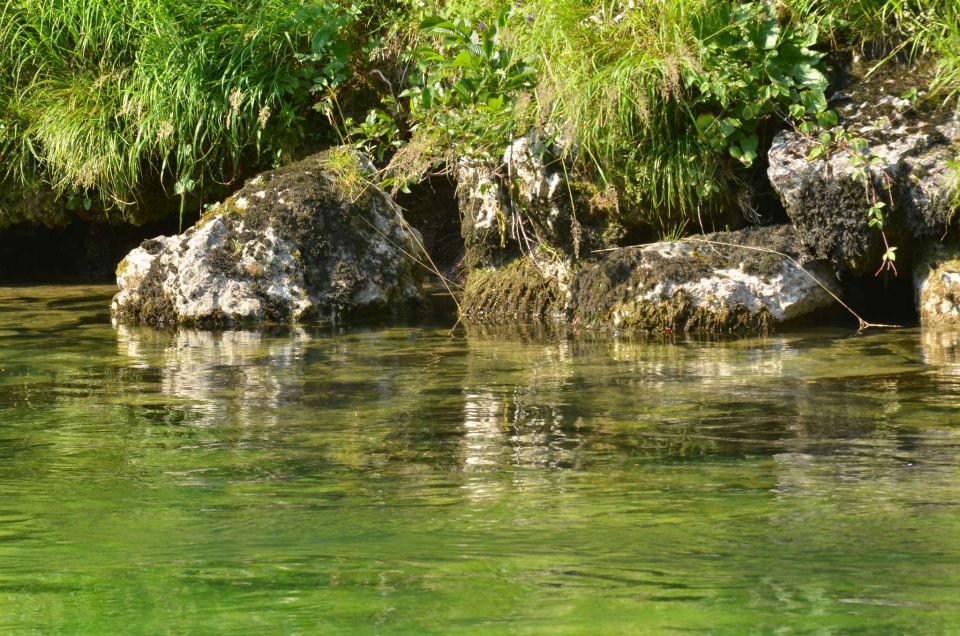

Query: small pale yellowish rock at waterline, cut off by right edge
<box><xmin>914</xmin><ymin>244</ymin><xmax>960</xmax><ymax>329</ymax></box>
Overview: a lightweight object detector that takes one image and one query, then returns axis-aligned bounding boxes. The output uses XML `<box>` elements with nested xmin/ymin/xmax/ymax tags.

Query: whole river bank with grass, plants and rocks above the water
<box><xmin>0</xmin><ymin>0</ymin><xmax>960</xmax><ymax>334</ymax></box>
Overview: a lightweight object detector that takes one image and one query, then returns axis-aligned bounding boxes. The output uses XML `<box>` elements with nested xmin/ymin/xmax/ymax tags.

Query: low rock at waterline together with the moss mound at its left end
<box><xmin>461</xmin><ymin>225</ymin><xmax>835</xmax><ymax>334</ymax></box>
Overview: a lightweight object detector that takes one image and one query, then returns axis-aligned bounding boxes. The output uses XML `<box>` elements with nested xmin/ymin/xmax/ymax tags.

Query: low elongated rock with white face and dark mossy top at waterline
<box><xmin>571</xmin><ymin>226</ymin><xmax>833</xmax><ymax>333</ymax></box>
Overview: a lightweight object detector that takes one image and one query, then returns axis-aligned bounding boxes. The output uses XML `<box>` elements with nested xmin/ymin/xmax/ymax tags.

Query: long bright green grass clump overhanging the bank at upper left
<box><xmin>0</xmin><ymin>0</ymin><xmax>357</xmax><ymax>224</ymax></box>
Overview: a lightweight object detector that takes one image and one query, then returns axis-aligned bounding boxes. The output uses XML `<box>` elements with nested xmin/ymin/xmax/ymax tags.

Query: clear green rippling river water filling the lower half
<box><xmin>0</xmin><ymin>286</ymin><xmax>960</xmax><ymax>634</ymax></box>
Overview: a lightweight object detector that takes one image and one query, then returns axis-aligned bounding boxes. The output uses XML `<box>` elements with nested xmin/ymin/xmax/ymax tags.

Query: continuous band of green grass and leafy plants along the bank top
<box><xmin>0</xmin><ymin>0</ymin><xmax>960</xmax><ymax>235</ymax></box>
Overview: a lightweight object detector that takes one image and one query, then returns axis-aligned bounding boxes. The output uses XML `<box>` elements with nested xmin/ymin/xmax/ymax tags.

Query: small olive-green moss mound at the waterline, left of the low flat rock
<box><xmin>460</xmin><ymin>257</ymin><xmax>566</xmax><ymax>322</ymax></box>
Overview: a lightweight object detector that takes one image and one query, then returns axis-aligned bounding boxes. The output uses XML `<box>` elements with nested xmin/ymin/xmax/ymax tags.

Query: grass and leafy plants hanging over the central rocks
<box><xmin>386</xmin><ymin>0</ymin><xmax>826</xmax><ymax>227</ymax></box>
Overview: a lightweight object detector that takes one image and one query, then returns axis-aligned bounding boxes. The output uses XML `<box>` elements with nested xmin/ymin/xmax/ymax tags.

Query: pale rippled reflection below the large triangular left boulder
<box><xmin>117</xmin><ymin>325</ymin><xmax>310</xmax><ymax>425</ymax></box>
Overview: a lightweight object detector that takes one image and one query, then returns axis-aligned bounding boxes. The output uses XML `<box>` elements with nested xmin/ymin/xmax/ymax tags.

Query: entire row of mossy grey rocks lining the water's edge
<box><xmin>113</xmin><ymin>62</ymin><xmax>960</xmax><ymax>334</ymax></box>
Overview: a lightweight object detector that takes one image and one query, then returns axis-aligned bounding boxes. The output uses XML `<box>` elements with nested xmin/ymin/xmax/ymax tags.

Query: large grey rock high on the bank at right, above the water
<box><xmin>768</xmin><ymin>61</ymin><xmax>960</xmax><ymax>274</ymax></box>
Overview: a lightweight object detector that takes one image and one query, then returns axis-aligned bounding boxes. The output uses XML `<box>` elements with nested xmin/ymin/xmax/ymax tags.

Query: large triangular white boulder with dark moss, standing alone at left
<box><xmin>112</xmin><ymin>149</ymin><xmax>422</xmax><ymax>325</ymax></box>
